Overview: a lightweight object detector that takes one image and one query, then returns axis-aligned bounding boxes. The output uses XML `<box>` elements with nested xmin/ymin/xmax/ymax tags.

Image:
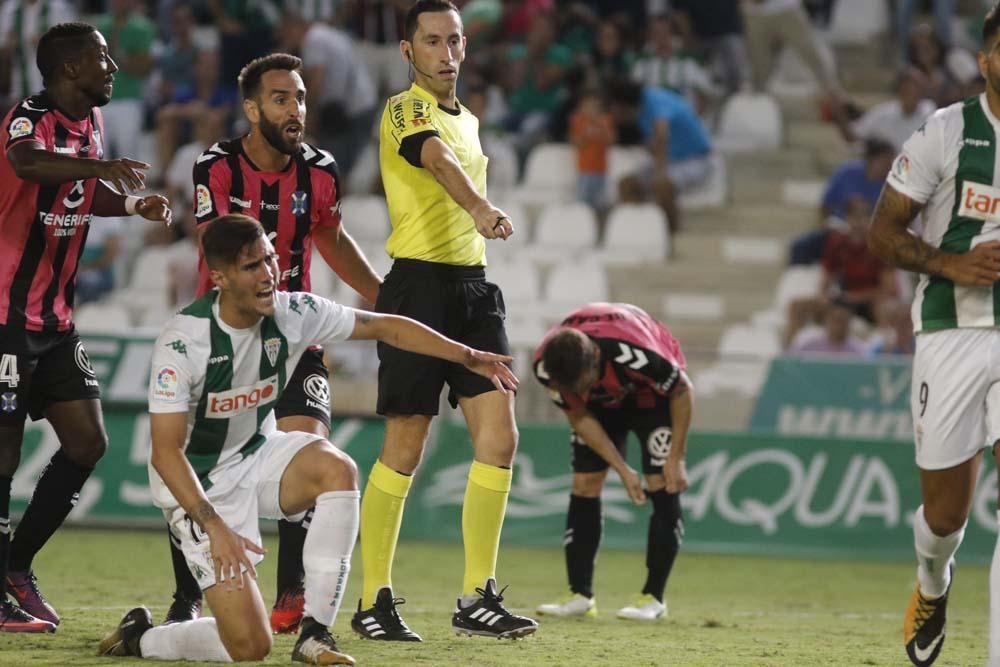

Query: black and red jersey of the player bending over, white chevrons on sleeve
<box><xmin>533</xmin><ymin>303</ymin><xmax>687</xmax><ymax>410</ymax></box>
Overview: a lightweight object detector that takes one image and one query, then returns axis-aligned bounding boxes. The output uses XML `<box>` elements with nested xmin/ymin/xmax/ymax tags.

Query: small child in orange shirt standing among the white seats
<box><xmin>569</xmin><ymin>89</ymin><xmax>617</xmax><ymax>213</ymax></box>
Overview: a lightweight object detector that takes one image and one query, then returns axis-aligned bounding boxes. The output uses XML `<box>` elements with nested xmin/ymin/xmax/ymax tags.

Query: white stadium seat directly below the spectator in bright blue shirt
<box><xmin>600</xmin><ymin>204</ymin><xmax>670</xmax><ymax>264</ymax></box>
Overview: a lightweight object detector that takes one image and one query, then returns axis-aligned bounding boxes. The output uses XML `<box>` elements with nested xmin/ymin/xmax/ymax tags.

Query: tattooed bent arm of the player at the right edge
<box><xmin>868</xmin><ymin>185</ymin><xmax>1000</xmax><ymax>287</ymax></box>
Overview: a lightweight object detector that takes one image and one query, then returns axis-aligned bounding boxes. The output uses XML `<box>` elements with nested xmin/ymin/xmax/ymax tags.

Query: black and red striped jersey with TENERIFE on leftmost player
<box><xmin>0</xmin><ymin>93</ymin><xmax>104</xmax><ymax>331</ymax></box>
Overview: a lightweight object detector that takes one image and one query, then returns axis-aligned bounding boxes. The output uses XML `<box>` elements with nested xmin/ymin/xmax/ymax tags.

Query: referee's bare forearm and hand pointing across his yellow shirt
<box><xmin>420</xmin><ymin>137</ymin><xmax>514</xmax><ymax>239</ymax></box>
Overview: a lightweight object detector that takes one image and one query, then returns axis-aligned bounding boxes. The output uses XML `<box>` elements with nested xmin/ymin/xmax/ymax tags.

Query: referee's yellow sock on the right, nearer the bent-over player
<box><xmin>462</xmin><ymin>461</ymin><xmax>513</xmax><ymax>596</ymax></box>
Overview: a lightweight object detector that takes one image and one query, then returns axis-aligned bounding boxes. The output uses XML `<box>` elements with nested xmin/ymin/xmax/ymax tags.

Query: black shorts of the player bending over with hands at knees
<box><xmin>570</xmin><ymin>398</ymin><xmax>671</xmax><ymax>475</ymax></box>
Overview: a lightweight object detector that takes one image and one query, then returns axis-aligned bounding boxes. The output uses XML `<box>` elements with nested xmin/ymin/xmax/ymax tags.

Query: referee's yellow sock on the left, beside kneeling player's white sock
<box><xmin>361</xmin><ymin>461</ymin><xmax>413</xmax><ymax>606</ymax></box>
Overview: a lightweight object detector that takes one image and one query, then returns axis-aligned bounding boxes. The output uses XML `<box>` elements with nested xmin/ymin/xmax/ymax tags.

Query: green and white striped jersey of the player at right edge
<box><xmin>888</xmin><ymin>95</ymin><xmax>1000</xmax><ymax>332</ymax></box>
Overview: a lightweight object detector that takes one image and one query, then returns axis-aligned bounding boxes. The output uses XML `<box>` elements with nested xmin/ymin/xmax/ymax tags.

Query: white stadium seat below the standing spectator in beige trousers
<box><xmin>715</xmin><ymin>93</ymin><xmax>782</xmax><ymax>153</ymax></box>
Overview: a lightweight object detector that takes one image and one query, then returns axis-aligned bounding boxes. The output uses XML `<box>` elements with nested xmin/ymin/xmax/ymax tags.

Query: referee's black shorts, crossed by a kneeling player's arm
<box><xmin>375</xmin><ymin>259</ymin><xmax>510</xmax><ymax>415</ymax></box>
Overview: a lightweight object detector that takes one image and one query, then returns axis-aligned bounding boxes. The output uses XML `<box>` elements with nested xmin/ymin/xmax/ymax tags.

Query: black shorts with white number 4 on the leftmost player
<box><xmin>0</xmin><ymin>326</ymin><xmax>101</xmax><ymax>426</ymax></box>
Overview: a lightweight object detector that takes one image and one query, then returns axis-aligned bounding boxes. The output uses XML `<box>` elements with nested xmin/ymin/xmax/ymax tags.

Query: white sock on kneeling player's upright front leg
<box><xmin>302</xmin><ymin>490</ymin><xmax>361</xmax><ymax>626</ymax></box>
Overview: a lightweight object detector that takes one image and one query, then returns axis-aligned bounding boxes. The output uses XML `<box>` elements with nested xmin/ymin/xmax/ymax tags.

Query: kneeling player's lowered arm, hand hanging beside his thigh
<box><xmin>149</xmin><ymin>412</ymin><xmax>264</xmax><ymax>588</ymax></box>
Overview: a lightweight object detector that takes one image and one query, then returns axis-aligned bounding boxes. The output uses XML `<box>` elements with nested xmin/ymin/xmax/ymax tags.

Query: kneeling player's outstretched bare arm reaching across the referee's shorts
<box><xmin>351</xmin><ymin>310</ymin><xmax>519</xmax><ymax>393</ymax></box>
